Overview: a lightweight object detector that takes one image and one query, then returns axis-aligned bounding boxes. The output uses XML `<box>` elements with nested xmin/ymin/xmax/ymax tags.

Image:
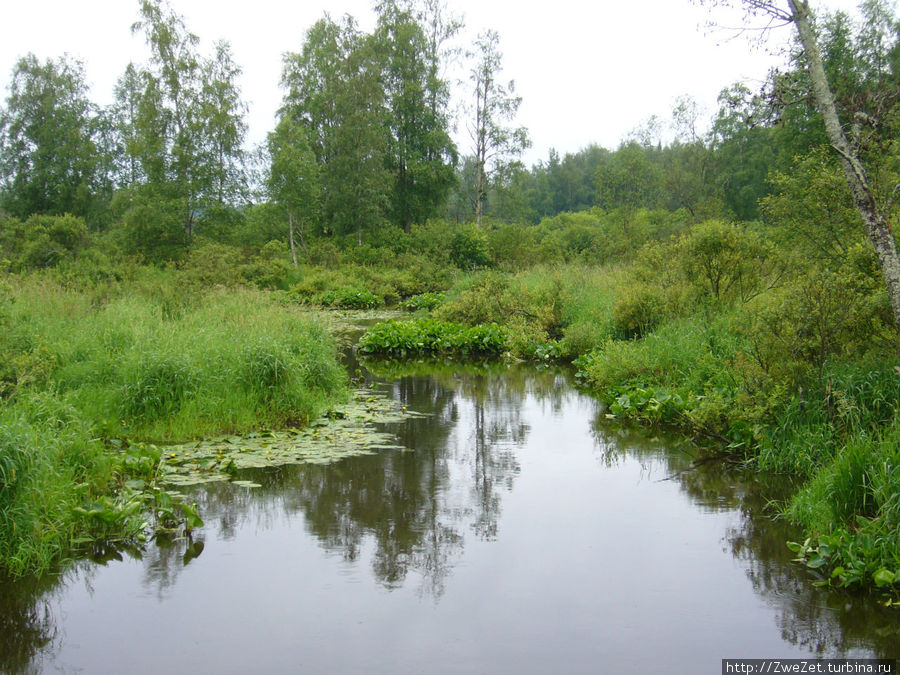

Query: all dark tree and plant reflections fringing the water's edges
<box><xmin>0</xmin><ymin>365</ymin><xmax>900</xmax><ymax>672</ymax></box>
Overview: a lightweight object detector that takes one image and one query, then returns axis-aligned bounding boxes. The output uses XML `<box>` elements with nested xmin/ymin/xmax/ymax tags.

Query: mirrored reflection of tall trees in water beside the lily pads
<box><xmin>137</xmin><ymin>365</ymin><xmax>552</xmax><ymax>597</ymax></box>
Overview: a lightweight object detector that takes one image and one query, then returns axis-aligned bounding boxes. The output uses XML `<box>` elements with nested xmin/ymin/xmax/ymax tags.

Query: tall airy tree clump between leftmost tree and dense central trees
<box><xmin>126</xmin><ymin>0</ymin><xmax>246</xmax><ymax>228</ymax></box>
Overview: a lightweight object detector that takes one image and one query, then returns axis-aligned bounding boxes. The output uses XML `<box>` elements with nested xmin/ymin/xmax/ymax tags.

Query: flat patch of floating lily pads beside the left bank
<box><xmin>162</xmin><ymin>389</ymin><xmax>424</xmax><ymax>487</ymax></box>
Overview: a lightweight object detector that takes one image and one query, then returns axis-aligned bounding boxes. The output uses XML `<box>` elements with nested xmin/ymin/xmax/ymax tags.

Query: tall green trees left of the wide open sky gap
<box><xmin>0</xmin><ymin>0</ymin><xmax>528</xmax><ymax>260</ymax></box>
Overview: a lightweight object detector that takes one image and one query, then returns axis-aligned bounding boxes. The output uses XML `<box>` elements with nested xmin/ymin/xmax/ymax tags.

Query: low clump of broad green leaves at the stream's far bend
<box><xmin>359</xmin><ymin>319</ymin><xmax>507</xmax><ymax>358</ymax></box>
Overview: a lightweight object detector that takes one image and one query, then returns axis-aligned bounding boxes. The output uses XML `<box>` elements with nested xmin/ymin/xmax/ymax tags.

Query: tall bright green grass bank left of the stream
<box><xmin>0</xmin><ymin>270</ymin><xmax>345</xmax><ymax>574</ymax></box>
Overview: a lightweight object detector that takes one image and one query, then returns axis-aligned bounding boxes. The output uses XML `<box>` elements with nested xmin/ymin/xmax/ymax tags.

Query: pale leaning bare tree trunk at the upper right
<box><xmin>788</xmin><ymin>0</ymin><xmax>900</xmax><ymax>331</ymax></box>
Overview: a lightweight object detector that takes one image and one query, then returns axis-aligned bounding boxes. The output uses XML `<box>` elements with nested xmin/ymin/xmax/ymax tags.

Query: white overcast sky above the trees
<box><xmin>0</xmin><ymin>0</ymin><xmax>857</xmax><ymax>164</ymax></box>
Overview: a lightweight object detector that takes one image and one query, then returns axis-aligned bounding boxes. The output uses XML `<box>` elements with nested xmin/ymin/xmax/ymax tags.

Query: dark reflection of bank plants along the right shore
<box><xmin>592</xmin><ymin>410</ymin><xmax>900</xmax><ymax>658</ymax></box>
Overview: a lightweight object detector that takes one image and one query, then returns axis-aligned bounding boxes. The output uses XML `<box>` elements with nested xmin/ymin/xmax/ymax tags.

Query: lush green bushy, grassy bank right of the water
<box><xmin>364</xmin><ymin>230</ymin><xmax>900</xmax><ymax>587</ymax></box>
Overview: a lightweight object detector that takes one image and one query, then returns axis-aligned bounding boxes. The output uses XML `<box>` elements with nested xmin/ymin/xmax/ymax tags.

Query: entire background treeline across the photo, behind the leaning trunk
<box><xmin>0</xmin><ymin>0</ymin><xmax>900</xmax><ymax>267</ymax></box>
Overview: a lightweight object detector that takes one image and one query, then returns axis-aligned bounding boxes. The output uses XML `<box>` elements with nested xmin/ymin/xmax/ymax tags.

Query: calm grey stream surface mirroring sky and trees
<box><xmin>0</xmin><ymin>367</ymin><xmax>900</xmax><ymax>673</ymax></box>
